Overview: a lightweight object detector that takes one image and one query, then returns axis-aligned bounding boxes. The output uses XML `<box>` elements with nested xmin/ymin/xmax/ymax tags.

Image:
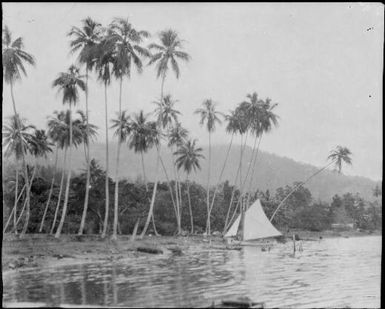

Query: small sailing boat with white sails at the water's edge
<box><xmin>224</xmin><ymin>199</ymin><xmax>282</xmax><ymax>246</ymax></box>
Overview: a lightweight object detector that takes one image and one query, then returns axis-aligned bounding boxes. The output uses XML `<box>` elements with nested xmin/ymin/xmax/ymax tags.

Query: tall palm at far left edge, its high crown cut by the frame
<box><xmin>2</xmin><ymin>25</ymin><xmax>35</xmax><ymax>236</ymax></box>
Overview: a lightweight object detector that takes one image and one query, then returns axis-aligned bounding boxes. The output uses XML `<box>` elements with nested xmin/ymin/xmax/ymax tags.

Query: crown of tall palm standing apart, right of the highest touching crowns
<box><xmin>148</xmin><ymin>29</ymin><xmax>190</xmax><ymax>78</ymax></box>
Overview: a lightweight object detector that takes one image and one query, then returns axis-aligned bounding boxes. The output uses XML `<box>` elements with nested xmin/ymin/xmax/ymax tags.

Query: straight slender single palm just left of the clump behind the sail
<box><xmin>194</xmin><ymin>99</ymin><xmax>223</xmax><ymax>235</ymax></box>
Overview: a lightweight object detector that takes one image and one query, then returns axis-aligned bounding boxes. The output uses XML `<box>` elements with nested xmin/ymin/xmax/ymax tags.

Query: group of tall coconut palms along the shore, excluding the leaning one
<box><xmin>2</xmin><ymin>17</ymin><xmax>352</xmax><ymax>239</ymax></box>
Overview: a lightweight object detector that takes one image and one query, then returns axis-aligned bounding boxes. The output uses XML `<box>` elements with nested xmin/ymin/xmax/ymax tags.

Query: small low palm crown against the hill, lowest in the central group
<box><xmin>174</xmin><ymin>140</ymin><xmax>204</xmax><ymax>174</ymax></box>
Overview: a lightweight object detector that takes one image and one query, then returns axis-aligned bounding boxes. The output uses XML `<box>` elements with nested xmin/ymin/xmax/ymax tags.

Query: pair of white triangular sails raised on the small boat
<box><xmin>225</xmin><ymin>199</ymin><xmax>282</xmax><ymax>240</ymax></box>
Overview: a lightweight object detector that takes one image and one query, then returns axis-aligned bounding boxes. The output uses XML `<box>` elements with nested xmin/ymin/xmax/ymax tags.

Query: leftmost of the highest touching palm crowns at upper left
<box><xmin>68</xmin><ymin>17</ymin><xmax>101</xmax><ymax>70</ymax></box>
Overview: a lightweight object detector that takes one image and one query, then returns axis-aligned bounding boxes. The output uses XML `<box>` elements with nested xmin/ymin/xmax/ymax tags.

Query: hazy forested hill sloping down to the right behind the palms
<box><xmin>32</xmin><ymin>143</ymin><xmax>377</xmax><ymax>201</ymax></box>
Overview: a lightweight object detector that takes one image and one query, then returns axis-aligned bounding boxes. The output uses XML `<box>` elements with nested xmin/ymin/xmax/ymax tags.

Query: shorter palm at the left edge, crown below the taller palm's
<box><xmin>2</xmin><ymin>114</ymin><xmax>35</xmax><ymax>231</ymax></box>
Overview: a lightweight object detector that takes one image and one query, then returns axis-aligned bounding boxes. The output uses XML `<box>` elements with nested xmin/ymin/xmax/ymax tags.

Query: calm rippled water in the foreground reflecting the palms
<box><xmin>3</xmin><ymin>236</ymin><xmax>382</xmax><ymax>308</ymax></box>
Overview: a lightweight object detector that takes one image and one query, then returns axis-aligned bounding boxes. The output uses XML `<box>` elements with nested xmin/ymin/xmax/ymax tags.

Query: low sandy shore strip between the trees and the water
<box><xmin>2</xmin><ymin>229</ymin><xmax>382</xmax><ymax>278</ymax></box>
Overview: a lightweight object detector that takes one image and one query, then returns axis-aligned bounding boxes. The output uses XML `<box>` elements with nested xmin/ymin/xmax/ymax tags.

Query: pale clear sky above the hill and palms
<box><xmin>2</xmin><ymin>3</ymin><xmax>384</xmax><ymax>180</ymax></box>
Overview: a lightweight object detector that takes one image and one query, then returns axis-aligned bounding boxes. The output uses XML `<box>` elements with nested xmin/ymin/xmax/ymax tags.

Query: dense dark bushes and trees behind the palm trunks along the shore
<box><xmin>3</xmin><ymin>161</ymin><xmax>382</xmax><ymax>235</ymax></box>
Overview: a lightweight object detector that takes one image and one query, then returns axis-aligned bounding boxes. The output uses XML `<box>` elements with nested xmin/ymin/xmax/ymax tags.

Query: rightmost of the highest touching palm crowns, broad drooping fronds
<box><xmin>106</xmin><ymin>18</ymin><xmax>151</xmax><ymax>78</ymax></box>
